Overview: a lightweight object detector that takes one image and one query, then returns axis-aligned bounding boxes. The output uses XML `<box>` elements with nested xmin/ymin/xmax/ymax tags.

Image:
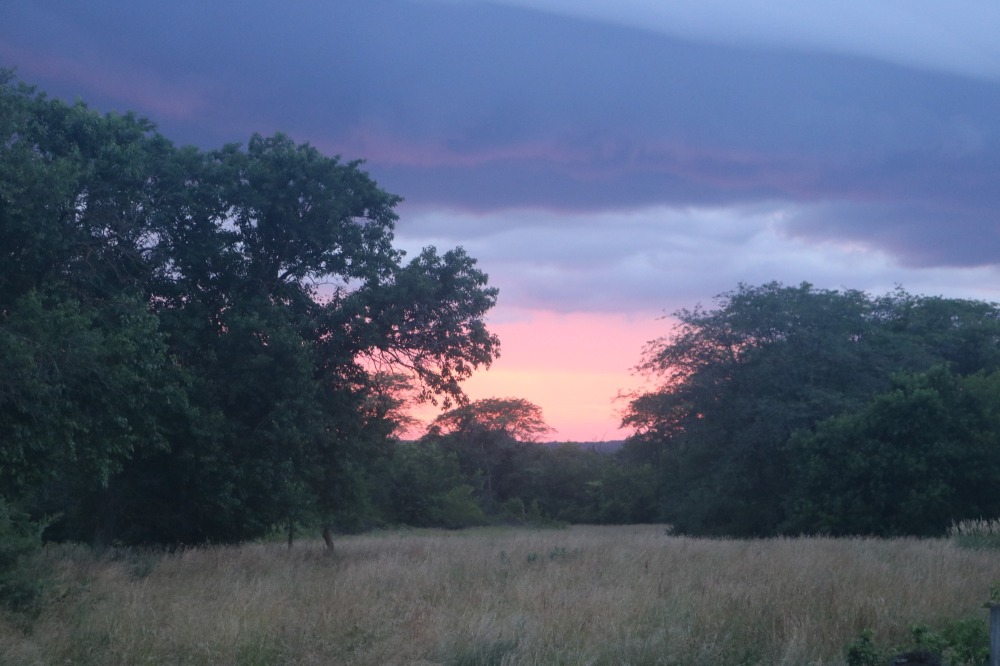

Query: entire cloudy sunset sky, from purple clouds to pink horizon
<box><xmin>0</xmin><ymin>0</ymin><xmax>1000</xmax><ymax>441</ymax></box>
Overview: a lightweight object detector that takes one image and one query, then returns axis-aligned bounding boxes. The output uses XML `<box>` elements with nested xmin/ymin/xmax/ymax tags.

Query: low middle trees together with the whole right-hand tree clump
<box><xmin>389</xmin><ymin>282</ymin><xmax>1000</xmax><ymax>537</ymax></box>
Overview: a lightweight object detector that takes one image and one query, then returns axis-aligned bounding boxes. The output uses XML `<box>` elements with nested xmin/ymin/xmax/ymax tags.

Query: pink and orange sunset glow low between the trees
<box><xmin>408</xmin><ymin>311</ymin><xmax>670</xmax><ymax>442</ymax></box>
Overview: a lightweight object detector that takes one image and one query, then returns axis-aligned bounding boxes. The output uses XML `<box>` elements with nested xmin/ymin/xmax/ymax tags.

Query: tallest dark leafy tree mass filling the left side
<box><xmin>0</xmin><ymin>74</ymin><xmax>498</xmax><ymax>542</ymax></box>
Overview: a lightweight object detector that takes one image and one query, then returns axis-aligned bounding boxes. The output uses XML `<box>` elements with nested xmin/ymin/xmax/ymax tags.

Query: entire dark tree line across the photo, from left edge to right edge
<box><xmin>0</xmin><ymin>72</ymin><xmax>1000</xmax><ymax>564</ymax></box>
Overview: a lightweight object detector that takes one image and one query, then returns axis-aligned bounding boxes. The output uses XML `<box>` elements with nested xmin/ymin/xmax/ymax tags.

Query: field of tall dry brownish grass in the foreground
<box><xmin>0</xmin><ymin>526</ymin><xmax>1000</xmax><ymax>666</ymax></box>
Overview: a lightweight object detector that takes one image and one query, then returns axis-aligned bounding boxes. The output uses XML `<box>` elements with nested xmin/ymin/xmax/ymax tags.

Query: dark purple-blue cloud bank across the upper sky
<box><xmin>0</xmin><ymin>0</ymin><xmax>1000</xmax><ymax>278</ymax></box>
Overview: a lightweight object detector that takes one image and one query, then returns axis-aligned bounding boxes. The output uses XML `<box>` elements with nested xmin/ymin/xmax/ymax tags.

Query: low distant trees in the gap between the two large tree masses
<box><xmin>378</xmin><ymin>398</ymin><xmax>657</xmax><ymax>527</ymax></box>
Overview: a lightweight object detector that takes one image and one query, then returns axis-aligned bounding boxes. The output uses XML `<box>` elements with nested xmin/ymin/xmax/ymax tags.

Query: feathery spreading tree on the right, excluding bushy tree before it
<box><xmin>624</xmin><ymin>283</ymin><xmax>1000</xmax><ymax>535</ymax></box>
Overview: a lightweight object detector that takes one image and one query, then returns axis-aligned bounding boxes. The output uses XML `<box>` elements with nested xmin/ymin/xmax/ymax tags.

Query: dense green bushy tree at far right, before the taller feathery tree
<box><xmin>787</xmin><ymin>366</ymin><xmax>1000</xmax><ymax>536</ymax></box>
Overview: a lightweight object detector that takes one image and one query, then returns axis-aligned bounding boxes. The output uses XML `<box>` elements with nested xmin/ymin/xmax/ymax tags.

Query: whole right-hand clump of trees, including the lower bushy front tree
<box><xmin>624</xmin><ymin>283</ymin><xmax>1000</xmax><ymax>536</ymax></box>
